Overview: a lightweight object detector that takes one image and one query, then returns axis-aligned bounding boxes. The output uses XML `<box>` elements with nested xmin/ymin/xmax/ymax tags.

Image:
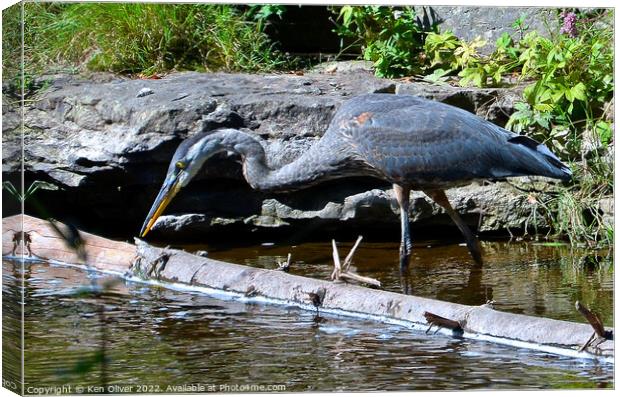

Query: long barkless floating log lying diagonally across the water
<box><xmin>2</xmin><ymin>216</ymin><xmax>614</xmax><ymax>361</ymax></box>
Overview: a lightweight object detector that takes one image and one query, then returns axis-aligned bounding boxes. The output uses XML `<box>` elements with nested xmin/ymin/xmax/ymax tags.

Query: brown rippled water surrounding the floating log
<box><xmin>3</xmin><ymin>238</ymin><xmax>613</xmax><ymax>393</ymax></box>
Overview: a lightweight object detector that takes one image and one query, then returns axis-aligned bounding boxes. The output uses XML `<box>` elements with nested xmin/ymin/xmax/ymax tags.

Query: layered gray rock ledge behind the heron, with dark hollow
<box><xmin>3</xmin><ymin>68</ymin><xmax>548</xmax><ymax>239</ymax></box>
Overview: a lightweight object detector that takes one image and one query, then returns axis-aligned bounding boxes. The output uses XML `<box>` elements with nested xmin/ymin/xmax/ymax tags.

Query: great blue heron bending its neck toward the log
<box><xmin>140</xmin><ymin>94</ymin><xmax>571</xmax><ymax>268</ymax></box>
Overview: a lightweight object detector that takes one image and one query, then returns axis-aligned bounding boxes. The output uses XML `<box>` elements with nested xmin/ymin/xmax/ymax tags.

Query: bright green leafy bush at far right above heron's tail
<box><xmin>508</xmin><ymin>15</ymin><xmax>613</xmax><ymax>158</ymax></box>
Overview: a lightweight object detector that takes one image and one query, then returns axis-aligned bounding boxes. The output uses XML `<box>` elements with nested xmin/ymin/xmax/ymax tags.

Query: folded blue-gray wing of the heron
<box><xmin>339</xmin><ymin>101</ymin><xmax>514</xmax><ymax>186</ymax></box>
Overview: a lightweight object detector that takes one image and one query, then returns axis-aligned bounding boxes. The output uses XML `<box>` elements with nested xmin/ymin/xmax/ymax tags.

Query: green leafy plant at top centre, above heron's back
<box><xmin>333</xmin><ymin>6</ymin><xmax>434</xmax><ymax>77</ymax></box>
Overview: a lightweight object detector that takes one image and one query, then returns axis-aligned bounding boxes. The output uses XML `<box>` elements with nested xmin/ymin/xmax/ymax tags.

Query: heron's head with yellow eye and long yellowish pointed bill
<box><xmin>140</xmin><ymin>134</ymin><xmax>222</xmax><ymax>237</ymax></box>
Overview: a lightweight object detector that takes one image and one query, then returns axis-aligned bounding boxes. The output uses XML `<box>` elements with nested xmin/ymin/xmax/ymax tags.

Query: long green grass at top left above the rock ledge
<box><xmin>5</xmin><ymin>2</ymin><xmax>283</xmax><ymax>75</ymax></box>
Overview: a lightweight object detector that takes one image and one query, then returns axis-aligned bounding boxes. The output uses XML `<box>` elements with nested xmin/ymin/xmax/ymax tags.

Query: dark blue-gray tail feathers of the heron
<box><xmin>508</xmin><ymin>135</ymin><xmax>572</xmax><ymax>181</ymax></box>
